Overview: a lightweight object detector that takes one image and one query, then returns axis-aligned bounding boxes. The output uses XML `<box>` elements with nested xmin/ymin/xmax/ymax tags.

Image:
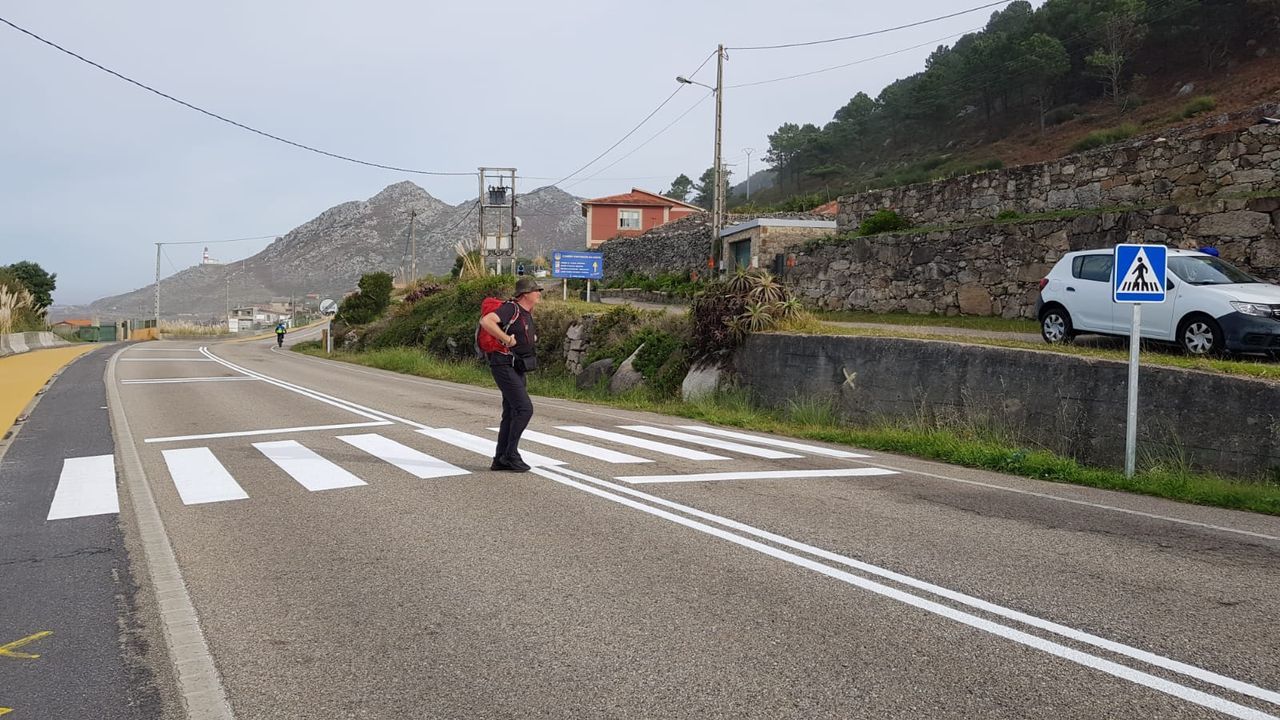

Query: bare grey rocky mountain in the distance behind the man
<box><xmin>84</xmin><ymin>182</ymin><xmax>586</xmax><ymax>320</ymax></box>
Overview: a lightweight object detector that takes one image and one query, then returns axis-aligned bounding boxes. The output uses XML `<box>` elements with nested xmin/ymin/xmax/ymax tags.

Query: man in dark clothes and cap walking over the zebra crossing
<box><xmin>480</xmin><ymin>277</ymin><xmax>543</xmax><ymax>473</ymax></box>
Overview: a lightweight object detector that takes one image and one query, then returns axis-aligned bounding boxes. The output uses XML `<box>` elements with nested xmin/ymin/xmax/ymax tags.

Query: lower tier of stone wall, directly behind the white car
<box><xmin>785</xmin><ymin>197</ymin><xmax>1280</xmax><ymax>318</ymax></box>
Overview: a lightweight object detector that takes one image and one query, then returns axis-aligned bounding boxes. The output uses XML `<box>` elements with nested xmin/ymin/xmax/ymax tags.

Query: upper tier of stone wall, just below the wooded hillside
<box><xmin>836</xmin><ymin>108</ymin><xmax>1280</xmax><ymax>232</ymax></box>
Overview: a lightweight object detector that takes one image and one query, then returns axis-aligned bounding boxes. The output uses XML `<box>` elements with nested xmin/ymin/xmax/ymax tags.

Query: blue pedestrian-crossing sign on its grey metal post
<box><xmin>1111</xmin><ymin>245</ymin><xmax>1169</xmax><ymax>478</ymax></box>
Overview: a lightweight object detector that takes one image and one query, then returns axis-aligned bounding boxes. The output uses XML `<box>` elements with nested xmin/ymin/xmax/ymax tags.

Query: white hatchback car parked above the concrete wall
<box><xmin>1036</xmin><ymin>249</ymin><xmax>1280</xmax><ymax>357</ymax></box>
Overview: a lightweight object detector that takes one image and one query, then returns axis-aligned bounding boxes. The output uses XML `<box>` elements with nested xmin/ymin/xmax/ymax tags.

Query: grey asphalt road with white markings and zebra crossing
<box><xmin>0</xmin><ymin>333</ymin><xmax>1280</xmax><ymax>720</ymax></box>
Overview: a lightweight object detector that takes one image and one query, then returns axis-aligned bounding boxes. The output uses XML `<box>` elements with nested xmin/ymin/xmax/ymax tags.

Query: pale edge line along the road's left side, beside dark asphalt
<box><xmin>104</xmin><ymin>348</ymin><xmax>234</xmax><ymax>720</ymax></box>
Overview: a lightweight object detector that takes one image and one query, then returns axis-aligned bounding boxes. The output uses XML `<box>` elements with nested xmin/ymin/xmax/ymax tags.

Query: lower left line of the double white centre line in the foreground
<box><xmin>534</xmin><ymin>468</ymin><xmax>1280</xmax><ymax>720</ymax></box>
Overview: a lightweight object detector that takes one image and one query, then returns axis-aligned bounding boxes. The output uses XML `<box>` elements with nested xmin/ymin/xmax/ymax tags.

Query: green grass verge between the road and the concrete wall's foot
<box><xmin>294</xmin><ymin>343</ymin><xmax>1280</xmax><ymax>515</ymax></box>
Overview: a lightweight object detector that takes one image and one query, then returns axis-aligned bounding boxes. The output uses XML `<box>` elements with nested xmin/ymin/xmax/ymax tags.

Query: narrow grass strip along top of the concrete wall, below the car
<box><xmin>786</xmin><ymin>322</ymin><xmax>1280</xmax><ymax>380</ymax></box>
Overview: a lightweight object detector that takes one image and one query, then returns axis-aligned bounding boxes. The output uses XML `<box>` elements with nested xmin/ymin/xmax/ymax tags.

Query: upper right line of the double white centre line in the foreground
<box><xmin>556</xmin><ymin>468</ymin><xmax>1280</xmax><ymax>705</ymax></box>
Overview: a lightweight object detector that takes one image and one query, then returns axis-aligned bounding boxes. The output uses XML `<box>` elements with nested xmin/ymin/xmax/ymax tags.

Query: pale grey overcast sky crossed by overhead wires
<box><xmin>0</xmin><ymin>0</ymin><xmax>1018</xmax><ymax>304</ymax></box>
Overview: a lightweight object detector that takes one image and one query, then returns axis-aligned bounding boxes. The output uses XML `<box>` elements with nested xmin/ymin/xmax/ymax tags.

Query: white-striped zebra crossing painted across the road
<box><xmin>47</xmin><ymin>424</ymin><xmax>896</xmax><ymax>520</ymax></box>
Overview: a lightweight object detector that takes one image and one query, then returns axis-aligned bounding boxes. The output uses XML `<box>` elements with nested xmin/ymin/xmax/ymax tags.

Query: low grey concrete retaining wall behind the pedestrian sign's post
<box><xmin>735</xmin><ymin>334</ymin><xmax>1280</xmax><ymax>477</ymax></box>
